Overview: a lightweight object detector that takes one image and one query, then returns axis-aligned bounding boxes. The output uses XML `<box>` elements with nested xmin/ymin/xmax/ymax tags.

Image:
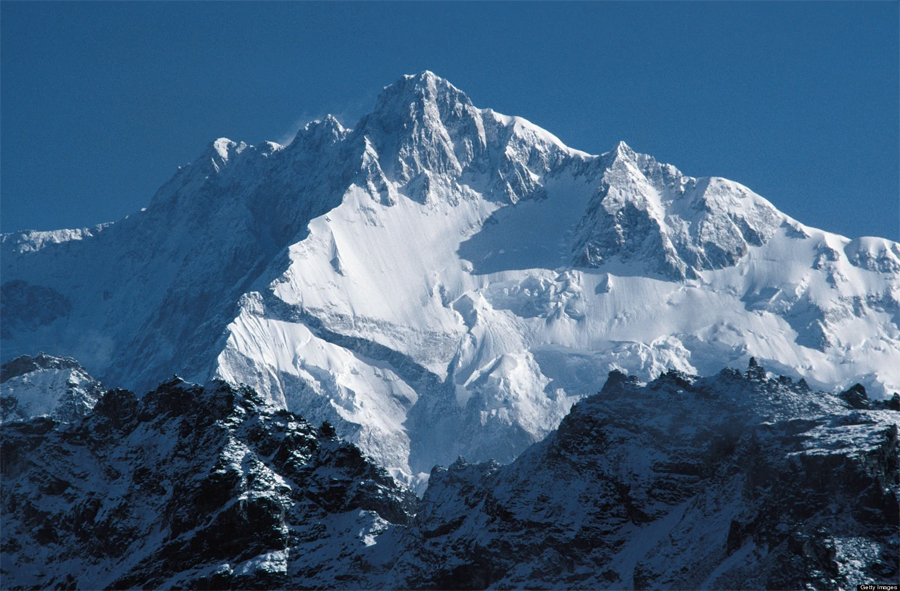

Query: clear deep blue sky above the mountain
<box><xmin>0</xmin><ymin>1</ymin><xmax>900</xmax><ymax>240</ymax></box>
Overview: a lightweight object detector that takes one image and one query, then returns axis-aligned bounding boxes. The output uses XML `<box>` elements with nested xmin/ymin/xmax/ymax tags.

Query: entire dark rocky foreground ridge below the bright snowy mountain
<box><xmin>0</xmin><ymin>362</ymin><xmax>900</xmax><ymax>589</ymax></box>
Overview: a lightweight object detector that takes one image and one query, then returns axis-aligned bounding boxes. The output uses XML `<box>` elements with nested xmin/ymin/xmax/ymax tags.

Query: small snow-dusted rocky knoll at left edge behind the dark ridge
<box><xmin>0</xmin><ymin>353</ymin><xmax>105</xmax><ymax>423</ymax></box>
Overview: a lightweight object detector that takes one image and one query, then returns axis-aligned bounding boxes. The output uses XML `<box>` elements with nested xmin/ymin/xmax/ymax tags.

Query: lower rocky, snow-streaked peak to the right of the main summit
<box><xmin>573</xmin><ymin>142</ymin><xmax>784</xmax><ymax>280</ymax></box>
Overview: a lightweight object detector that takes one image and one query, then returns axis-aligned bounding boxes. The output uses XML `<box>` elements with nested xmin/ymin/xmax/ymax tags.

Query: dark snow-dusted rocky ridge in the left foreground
<box><xmin>0</xmin><ymin>379</ymin><xmax>416</xmax><ymax>589</ymax></box>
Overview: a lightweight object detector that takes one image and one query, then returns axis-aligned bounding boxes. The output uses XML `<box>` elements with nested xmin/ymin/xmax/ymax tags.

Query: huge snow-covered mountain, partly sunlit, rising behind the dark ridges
<box><xmin>0</xmin><ymin>72</ymin><xmax>900</xmax><ymax>478</ymax></box>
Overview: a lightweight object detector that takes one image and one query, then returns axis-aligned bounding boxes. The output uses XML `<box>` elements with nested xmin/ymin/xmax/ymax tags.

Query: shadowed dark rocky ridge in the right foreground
<box><xmin>397</xmin><ymin>362</ymin><xmax>900</xmax><ymax>589</ymax></box>
